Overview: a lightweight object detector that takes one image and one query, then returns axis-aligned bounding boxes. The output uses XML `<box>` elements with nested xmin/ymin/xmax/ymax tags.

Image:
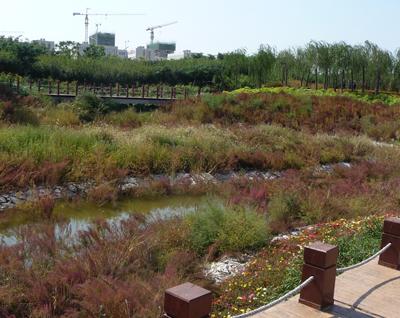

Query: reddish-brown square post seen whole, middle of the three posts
<box><xmin>299</xmin><ymin>242</ymin><xmax>339</xmax><ymax>310</ymax></box>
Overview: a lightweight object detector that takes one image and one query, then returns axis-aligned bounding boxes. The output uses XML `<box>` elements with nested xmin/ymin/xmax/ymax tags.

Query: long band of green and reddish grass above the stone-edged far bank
<box><xmin>0</xmin><ymin>125</ymin><xmax>382</xmax><ymax>188</ymax></box>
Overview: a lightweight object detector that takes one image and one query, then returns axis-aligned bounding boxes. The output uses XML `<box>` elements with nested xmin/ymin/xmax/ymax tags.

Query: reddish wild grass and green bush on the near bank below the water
<box><xmin>0</xmin><ymin>200</ymin><xmax>267</xmax><ymax>317</ymax></box>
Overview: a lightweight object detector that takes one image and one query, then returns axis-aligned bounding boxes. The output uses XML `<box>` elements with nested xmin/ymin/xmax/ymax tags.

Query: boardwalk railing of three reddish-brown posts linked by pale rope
<box><xmin>164</xmin><ymin>218</ymin><xmax>400</xmax><ymax>318</ymax></box>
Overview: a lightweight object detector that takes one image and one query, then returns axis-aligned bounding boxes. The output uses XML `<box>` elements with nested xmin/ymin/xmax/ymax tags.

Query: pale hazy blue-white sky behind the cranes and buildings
<box><xmin>0</xmin><ymin>0</ymin><xmax>400</xmax><ymax>53</ymax></box>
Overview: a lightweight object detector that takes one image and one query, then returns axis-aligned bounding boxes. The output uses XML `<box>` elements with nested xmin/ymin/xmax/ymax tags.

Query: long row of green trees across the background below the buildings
<box><xmin>0</xmin><ymin>37</ymin><xmax>400</xmax><ymax>93</ymax></box>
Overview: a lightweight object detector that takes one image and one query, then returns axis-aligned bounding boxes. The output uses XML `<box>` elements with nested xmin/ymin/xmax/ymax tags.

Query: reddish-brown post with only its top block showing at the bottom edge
<box><xmin>164</xmin><ymin>283</ymin><xmax>212</xmax><ymax>318</ymax></box>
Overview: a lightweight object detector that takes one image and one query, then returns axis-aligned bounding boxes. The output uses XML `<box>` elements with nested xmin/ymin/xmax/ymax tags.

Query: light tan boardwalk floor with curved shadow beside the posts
<box><xmin>254</xmin><ymin>259</ymin><xmax>400</xmax><ymax>318</ymax></box>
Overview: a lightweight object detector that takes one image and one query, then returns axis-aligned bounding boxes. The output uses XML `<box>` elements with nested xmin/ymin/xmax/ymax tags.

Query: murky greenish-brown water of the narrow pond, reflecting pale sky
<box><xmin>0</xmin><ymin>196</ymin><xmax>206</xmax><ymax>245</ymax></box>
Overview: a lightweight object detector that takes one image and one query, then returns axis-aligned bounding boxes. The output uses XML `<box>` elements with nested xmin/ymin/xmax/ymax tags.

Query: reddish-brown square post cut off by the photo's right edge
<box><xmin>379</xmin><ymin>218</ymin><xmax>400</xmax><ymax>270</ymax></box>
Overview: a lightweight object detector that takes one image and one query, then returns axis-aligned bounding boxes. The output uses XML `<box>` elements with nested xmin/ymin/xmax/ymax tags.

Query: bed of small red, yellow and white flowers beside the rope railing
<box><xmin>211</xmin><ymin>216</ymin><xmax>384</xmax><ymax>317</ymax></box>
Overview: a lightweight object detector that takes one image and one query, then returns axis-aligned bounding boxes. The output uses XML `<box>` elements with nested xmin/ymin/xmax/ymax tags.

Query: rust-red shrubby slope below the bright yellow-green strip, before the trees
<box><xmin>159</xmin><ymin>89</ymin><xmax>400</xmax><ymax>141</ymax></box>
